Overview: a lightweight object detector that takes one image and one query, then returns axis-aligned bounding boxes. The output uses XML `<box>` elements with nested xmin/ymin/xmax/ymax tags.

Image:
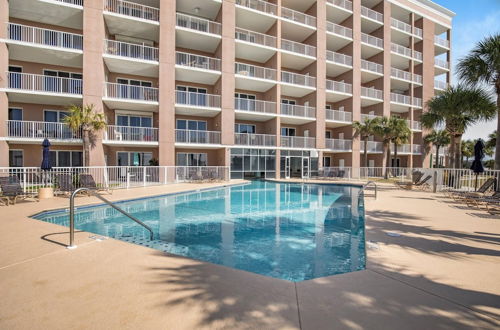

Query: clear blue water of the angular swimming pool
<box><xmin>34</xmin><ymin>181</ymin><xmax>365</xmax><ymax>281</ymax></box>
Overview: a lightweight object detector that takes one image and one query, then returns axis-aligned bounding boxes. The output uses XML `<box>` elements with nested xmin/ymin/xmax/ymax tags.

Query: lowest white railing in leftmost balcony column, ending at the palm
<box><xmin>7</xmin><ymin>120</ymin><xmax>82</xmax><ymax>140</ymax></box>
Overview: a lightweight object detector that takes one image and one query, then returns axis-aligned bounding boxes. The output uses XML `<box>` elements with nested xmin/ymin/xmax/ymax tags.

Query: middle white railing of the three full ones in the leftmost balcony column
<box><xmin>7</xmin><ymin>72</ymin><xmax>83</xmax><ymax>95</ymax></box>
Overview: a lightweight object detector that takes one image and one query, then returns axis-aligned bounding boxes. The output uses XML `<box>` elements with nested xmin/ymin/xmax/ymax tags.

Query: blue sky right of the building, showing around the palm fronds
<box><xmin>433</xmin><ymin>0</ymin><xmax>500</xmax><ymax>139</ymax></box>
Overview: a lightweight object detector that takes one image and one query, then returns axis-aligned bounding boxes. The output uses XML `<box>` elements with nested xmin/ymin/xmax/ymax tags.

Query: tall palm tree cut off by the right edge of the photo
<box><xmin>457</xmin><ymin>33</ymin><xmax>500</xmax><ymax>170</ymax></box>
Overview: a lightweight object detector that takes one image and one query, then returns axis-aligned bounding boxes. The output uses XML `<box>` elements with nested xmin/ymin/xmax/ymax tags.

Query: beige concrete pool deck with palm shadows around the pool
<box><xmin>0</xmin><ymin>184</ymin><xmax>500</xmax><ymax>329</ymax></box>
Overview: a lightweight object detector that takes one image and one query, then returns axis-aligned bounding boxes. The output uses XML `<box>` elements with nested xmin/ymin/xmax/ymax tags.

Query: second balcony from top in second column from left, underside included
<box><xmin>103</xmin><ymin>40</ymin><xmax>159</xmax><ymax>77</ymax></box>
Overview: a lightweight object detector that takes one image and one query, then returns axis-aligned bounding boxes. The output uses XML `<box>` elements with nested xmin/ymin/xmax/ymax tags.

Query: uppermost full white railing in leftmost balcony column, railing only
<box><xmin>7</xmin><ymin>23</ymin><xmax>83</xmax><ymax>50</ymax></box>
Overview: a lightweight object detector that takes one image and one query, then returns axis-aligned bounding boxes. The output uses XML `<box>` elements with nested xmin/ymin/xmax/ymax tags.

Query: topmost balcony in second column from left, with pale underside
<box><xmin>104</xmin><ymin>0</ymin><xmax>160</xmax><ymax>41</ymax></box>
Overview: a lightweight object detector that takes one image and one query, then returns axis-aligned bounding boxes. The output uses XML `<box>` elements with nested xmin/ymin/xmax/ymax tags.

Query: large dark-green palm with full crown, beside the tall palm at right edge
<box><xmin>420</xmin><ymin>84</ymin><xmax>496</xmax><ymax>168</ymax></box>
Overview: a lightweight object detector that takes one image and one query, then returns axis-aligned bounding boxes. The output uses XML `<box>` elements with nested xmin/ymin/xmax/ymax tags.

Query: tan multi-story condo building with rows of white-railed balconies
<box><xmin>0</xmin><ymin>0</ymin><xmax>454</xmax><ymax>178</ymax></box>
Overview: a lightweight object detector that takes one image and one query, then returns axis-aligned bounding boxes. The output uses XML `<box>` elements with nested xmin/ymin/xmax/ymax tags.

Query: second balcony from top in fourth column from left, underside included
<box><xmin>235</xmin><ymin>28</ymin><xmax>276</xmax><ymax>63</ymax></box>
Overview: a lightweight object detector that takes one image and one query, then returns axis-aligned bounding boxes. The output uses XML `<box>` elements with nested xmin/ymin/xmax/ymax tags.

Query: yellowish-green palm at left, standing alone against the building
<box><xmin>64</xmin><ymin>104</ymin><xmax>106</xmax><ymax>166</ymax></box>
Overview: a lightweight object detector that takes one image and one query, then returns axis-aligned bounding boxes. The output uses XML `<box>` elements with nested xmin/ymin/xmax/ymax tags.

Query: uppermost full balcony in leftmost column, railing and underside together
<box><xmin>6</xmin><ymin>23</ymin><xmax>83</xmax><ymax>67</ymax></box>
